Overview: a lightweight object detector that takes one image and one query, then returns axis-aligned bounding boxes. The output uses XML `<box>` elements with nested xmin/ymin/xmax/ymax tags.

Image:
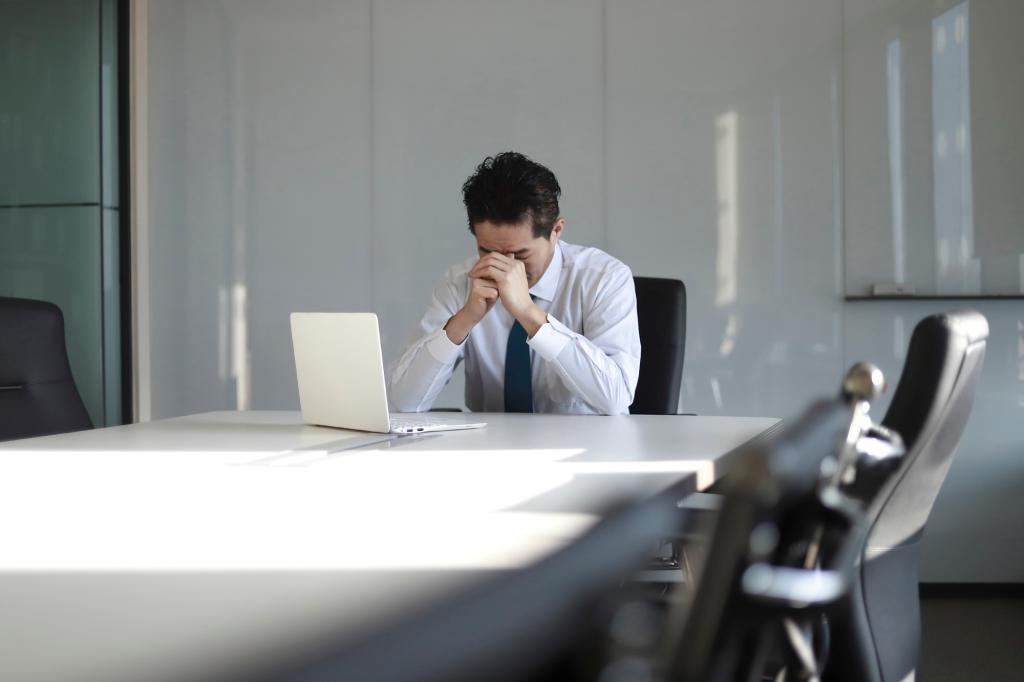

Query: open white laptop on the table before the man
<box><xmin>292</xmin><ymin>312</ymin><xmax>486</xmax><ymax>433</ymax></box>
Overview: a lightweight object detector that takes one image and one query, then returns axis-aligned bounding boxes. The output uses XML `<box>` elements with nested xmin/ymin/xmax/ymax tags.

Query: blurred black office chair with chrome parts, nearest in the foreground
<box><xmin>659</xmin><ymin>365</ymin><xmax>905</xmax><ymax>682</ymax></box>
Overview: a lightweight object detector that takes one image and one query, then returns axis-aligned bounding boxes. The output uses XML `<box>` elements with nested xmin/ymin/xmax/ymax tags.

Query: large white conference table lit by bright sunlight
<box><xmin>0</xmin><ymin>405</ymin><xmax>777</xmax><ymax>681</ymax></box>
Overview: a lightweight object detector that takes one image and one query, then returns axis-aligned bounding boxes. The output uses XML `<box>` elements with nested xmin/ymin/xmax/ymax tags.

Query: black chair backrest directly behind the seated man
<box><xmin>630</xmin><ymin>278</ymin><xmax>686</xmax><ymax>415</ymax></box>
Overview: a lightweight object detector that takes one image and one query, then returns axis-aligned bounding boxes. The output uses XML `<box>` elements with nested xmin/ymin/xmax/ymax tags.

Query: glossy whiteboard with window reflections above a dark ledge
<box><xmin>844</xmin><ymin>0</ymin><xmax>1024</xmax><ymax>297</ymax></box>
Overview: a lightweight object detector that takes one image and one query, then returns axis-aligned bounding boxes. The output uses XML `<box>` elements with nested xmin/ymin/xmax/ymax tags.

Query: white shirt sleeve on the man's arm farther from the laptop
<box><xmin>527</xmin><ymin>263</ymin><xmax>640</xmax><ymax>415</ymax></box>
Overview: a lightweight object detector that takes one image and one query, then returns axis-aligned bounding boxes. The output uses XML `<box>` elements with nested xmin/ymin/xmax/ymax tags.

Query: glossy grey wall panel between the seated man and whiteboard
<box><xmin>605</xmin><ymin>0</ymin><xmax>842</xmax><ymax>416</ymax></box>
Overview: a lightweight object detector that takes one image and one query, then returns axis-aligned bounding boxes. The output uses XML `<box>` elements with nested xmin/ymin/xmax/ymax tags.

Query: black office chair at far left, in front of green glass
<box><xmin>0</xmin><ymin>297</ymin><xmax>92</xmax><ymax>440</ymax></box>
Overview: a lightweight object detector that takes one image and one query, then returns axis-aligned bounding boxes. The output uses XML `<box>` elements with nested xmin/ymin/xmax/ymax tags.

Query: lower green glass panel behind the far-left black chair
<box><xmin>0</xmin><ymin>207</ymin><xmax>104</xmax><ymax>425</ymax></box>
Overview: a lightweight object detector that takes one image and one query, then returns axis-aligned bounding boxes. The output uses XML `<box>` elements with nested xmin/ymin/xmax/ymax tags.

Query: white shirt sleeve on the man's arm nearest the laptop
<box><xmin>387</xmin><ymin>272</ymin><xmax>466</xmax><ymax>412</ymax></box>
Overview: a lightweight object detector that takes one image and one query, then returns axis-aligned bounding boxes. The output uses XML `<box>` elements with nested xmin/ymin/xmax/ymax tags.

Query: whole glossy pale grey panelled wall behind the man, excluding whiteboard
<box><xmin>150</xmin><ymin>0</ymin><xmax>1024</xmax><ymax>581</ymax></box>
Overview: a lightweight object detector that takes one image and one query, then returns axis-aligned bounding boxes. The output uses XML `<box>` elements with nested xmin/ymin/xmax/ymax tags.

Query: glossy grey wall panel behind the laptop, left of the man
<box><xmin>150</xmin><ymin>0</ymin><xmax>374</xmax><ymax>417</ymax></box>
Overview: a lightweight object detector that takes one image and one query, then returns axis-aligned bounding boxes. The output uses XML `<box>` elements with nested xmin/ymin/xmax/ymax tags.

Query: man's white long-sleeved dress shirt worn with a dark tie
<box><xmin>388</xmin><ymin>241</ymin><xmax>640</xmax><ymax>415</ymax></box>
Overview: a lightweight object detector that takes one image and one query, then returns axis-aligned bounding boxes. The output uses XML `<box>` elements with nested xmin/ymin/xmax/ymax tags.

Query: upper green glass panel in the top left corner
<box><xmin>0</xmin><ymin>0</ymin><xmax>99</xmax><ymax>206</ymax></box>
